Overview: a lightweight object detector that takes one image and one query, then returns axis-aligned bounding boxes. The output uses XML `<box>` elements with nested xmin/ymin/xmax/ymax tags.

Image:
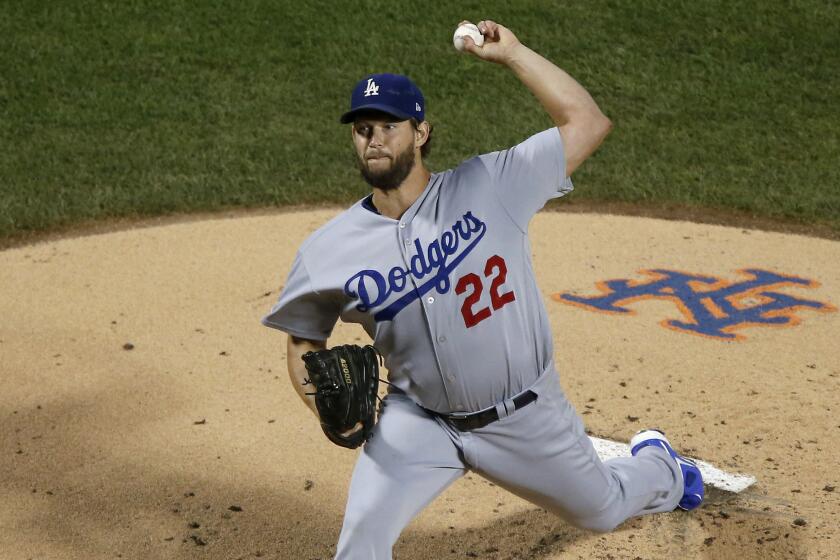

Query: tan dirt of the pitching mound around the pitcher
<box><xmin>0</xmin><ymin>209</ymin><xmax>840</xmax><ymax>560</ymax></box>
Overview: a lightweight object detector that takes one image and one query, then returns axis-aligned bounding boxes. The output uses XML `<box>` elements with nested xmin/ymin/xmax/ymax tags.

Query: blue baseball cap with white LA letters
<box><xmin>341</xmin><ymin>74</ymin><xmax>426</xmax><ymax>124</ymax></box>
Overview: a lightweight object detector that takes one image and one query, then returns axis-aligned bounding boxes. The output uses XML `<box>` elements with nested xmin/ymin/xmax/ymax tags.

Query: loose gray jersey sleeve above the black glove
<box><xmin>262</xmin><ymin>252</ymin><xmax>340</xmax><ymax>340</ymax></box>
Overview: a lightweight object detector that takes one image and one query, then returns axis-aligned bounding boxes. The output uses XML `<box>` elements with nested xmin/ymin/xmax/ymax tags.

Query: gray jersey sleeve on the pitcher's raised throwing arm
<box><xmin>479</xmin><ymin>127</ymin><xmax>573</xmax><ymax>231</ymax></box>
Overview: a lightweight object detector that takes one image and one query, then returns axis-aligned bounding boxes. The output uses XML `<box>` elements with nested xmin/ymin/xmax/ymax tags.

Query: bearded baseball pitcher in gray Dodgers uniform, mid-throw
<box><xmin>263</xmin><ymin>20</ymin><xmax>703</xmax><ymax>560</ymax></box>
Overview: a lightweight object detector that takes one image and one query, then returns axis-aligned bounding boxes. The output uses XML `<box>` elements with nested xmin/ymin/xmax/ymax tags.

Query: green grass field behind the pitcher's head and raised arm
<box><xmin>0</xmin><ymin>0</ymin><xmax>840</xmax><ymax>237</ymax></box>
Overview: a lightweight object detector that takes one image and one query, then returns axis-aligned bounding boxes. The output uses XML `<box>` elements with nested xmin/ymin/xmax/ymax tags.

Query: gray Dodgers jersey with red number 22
<box><xmin>263</xmin><ymin>128</ymin><xmax>572</xmax><ymax>412</ymax></box>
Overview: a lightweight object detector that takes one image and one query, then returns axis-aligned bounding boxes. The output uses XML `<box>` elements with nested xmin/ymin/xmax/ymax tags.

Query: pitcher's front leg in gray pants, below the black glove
<box><xmin>336</xmin><ymin>395</ymin><xmax>465</xmax><ymax>560</ymax></box>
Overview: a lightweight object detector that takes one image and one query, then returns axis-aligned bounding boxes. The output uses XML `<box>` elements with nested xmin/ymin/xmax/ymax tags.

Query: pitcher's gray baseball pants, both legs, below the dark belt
<box><xmin>336</xmin><ymin>367</ymin><xmax>683</xmax><ymax>560</ymax></box>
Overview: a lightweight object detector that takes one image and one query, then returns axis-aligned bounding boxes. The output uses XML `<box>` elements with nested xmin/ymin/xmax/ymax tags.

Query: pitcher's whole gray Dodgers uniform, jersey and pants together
<box><xmin>263</xmin><ymin>128</ymin><xmax>682</xmax><ymax>560</ymax></box>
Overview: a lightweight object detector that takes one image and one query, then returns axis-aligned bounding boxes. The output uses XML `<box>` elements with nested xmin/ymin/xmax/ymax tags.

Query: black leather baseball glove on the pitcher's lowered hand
<box><xmin>303</xmin><ymin>344</ymin><xmax>380</xmax><ymax>449</ymax></box>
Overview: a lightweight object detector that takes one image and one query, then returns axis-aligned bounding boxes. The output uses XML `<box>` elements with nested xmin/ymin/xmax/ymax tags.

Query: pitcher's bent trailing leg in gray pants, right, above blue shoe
<box><xmin>475</xmin><ymin>374</ymin><xmax>683</xmax><ymax>531</ymax></box>
